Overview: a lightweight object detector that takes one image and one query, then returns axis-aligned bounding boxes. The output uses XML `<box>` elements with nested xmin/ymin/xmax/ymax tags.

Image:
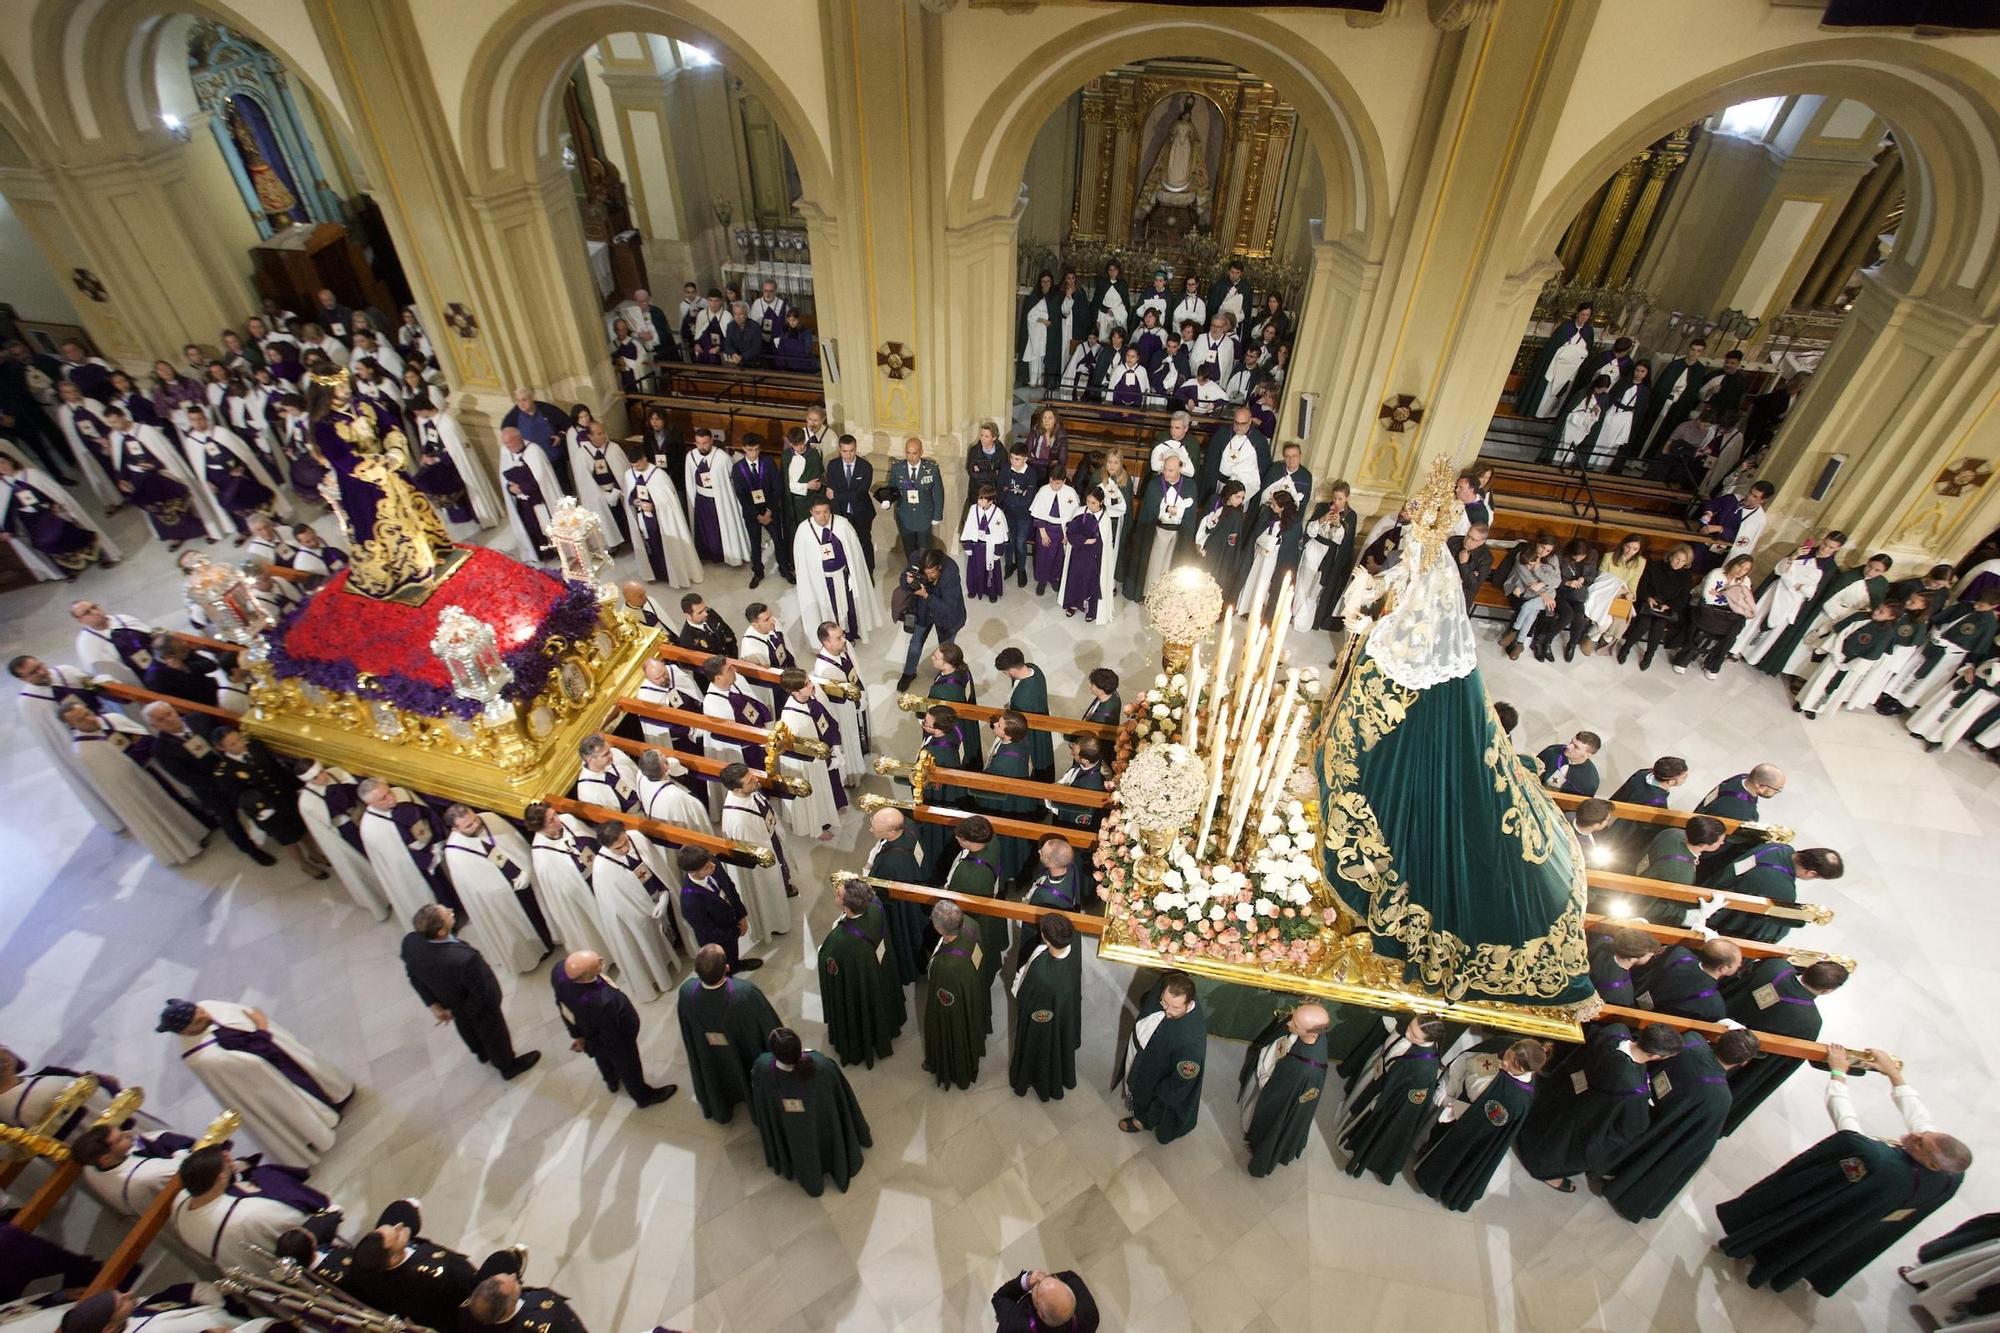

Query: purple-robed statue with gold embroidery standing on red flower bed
<box><xmin>308</xmin><ymin>360</ymin><xmax>466</xmax><ymax>600</ymax></box>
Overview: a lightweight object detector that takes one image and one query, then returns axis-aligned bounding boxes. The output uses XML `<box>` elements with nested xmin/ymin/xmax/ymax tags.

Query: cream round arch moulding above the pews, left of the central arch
<box><xmin>458</xmin><ymin>0</ymin><xmax>834</xmax><ymax>202</ymax></box>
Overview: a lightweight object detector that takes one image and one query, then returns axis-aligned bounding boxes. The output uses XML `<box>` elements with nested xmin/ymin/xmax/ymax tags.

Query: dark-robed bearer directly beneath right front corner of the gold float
<box><xmin>1514</xmin><ymin>1023</ymin><xmax>1680</xmax><ymax>1195</ymax></box>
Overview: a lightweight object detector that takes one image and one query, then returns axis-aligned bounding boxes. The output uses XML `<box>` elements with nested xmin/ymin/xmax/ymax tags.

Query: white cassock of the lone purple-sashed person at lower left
<box><xmin>180</xmin><ymin>1001</ymin><xmax>354</xmax><ymax>1167</ymax></box>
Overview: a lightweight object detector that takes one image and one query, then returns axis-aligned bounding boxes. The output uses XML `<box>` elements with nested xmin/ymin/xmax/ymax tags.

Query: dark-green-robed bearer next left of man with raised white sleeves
<box><xmin>1604</xmin><ymin>1029</ymin><xmax>1758</xmax><ymax>1221</ymax></box>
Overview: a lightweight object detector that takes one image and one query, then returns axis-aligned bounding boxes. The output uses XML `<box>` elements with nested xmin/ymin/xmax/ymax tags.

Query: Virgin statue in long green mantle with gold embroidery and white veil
<box><xmin>1314</xmin><ymin>458</ymin><xmax>1594</xmax><ymax>1009</ymax></box>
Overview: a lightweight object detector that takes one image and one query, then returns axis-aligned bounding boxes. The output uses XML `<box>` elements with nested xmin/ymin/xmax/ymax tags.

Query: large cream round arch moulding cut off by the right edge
<box><xmin>1514</xmin><ymin>38</ymin><xmax>2000</xmax><ymax>308</ymax></box>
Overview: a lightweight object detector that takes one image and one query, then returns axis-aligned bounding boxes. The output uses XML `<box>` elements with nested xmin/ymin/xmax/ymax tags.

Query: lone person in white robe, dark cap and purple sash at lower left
<box><xmin>156</xmin><ymin>999</ymin><xmax>354</xmax><ymax>1167</ymax></box>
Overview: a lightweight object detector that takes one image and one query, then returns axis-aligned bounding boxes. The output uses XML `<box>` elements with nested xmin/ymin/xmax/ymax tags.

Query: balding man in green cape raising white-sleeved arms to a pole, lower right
<box><xmin>1716</xmin><ymin>1047</ymin><xmax>1972</xmax><ymax>1295</ymax></box>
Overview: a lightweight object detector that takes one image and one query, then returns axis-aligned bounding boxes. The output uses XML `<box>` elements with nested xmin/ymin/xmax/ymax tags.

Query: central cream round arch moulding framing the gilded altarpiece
<box><xmin>946</xmin><ymin>10</ymin><xmax>1390</xmax><ymax>258</ymax></box>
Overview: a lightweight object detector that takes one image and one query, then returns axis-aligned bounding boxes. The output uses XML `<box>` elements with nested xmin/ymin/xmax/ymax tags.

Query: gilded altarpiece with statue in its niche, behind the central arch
<box><xmin>1070</xmin><ymin>64</ymin><xmax>1298</xmax><ymax>258</ymax></box>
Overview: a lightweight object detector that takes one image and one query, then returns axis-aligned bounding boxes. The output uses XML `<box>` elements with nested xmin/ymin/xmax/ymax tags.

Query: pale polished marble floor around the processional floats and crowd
<box><xmin>0</xmin><ymin>500</ymin><xmax>2000</xmax><ymax>1333</ymax></box>
